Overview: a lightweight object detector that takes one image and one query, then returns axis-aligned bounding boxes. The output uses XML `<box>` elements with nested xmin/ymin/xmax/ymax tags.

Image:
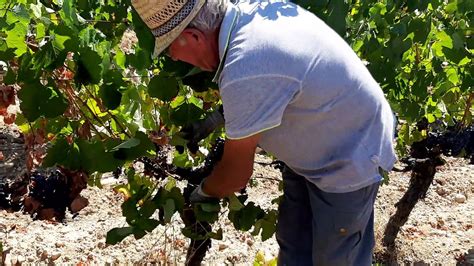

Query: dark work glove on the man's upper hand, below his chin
<box><xmin>181</xmin><ymin>108</ymin><xmax>225</xmax><ymax>153</ymax></box>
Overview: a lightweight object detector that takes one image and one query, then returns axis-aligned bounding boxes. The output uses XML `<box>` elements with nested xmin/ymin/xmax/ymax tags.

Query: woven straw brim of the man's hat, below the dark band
<box><xmin>153</xmin><ymin>0</ymin><xmax>206</xmax><ymax>57</ymax></box>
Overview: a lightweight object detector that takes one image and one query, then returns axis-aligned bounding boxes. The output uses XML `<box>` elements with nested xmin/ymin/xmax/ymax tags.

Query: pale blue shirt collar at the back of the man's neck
<box><xmin>212</xmin><ymin>3</ymin><xmax>239</xmax><ymax>82</ymax></box>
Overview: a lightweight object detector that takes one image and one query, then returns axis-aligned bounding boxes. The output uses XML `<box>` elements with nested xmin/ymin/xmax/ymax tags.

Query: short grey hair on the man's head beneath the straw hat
<box><xmin>189</xmin><ymin>0</ymin><xmax>229</xmax><ymax>32</ymax></box>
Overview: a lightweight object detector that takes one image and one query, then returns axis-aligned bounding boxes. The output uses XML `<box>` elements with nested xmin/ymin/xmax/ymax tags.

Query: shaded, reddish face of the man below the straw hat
<box><xmin>168</xmin><ymin>28</ymin><xmax>219</xmax><ymax>71</ymax></box>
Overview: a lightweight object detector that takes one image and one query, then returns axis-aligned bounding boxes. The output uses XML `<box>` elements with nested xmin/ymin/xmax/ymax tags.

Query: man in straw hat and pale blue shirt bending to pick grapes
<box><xmin>132</xmin><ymin>0</ymin><xmax>396</xmax><ymax>265</ymax></box>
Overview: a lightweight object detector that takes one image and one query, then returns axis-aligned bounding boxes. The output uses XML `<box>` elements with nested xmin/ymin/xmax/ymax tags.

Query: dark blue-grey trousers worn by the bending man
<box><xmin>276</xmin><ymin>167</ymin><xmax>379</xmax><ymax>266</ymax></box>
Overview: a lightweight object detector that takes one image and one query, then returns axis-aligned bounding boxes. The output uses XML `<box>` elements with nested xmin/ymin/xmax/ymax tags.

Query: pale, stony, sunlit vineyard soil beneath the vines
<box><xmin>0</xmin><ymin>140</ymin><xmax>474</xmax><ymax>265</ymax></box>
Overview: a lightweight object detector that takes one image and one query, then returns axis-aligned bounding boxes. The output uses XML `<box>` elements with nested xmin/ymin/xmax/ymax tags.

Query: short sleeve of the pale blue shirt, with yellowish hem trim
<box><xmin>220</xmin><ymin>75</ymin><xmax>301</xmax><ymax>139</ymax></box>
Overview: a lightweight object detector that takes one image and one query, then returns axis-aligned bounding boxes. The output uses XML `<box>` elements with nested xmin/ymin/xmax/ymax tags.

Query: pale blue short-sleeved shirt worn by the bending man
<box><xmin>216</xmin><ymin>1</ymin><xmax>396</xmax><ymax>193</ymax></box>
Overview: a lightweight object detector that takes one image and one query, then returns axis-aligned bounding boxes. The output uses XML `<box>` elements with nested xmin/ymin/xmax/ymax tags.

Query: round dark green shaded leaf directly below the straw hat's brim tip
<box><xmin>148</xmin><ymin>75</ymin><xmax>179</xmax><ymax>101</ymax></box>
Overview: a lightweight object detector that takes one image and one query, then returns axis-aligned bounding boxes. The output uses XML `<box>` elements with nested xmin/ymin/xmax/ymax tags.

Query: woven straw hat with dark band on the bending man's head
<box><xmin>132</xmin><ymin>0</ymin><xmax>206</xmax><ymax>56</ymax></box>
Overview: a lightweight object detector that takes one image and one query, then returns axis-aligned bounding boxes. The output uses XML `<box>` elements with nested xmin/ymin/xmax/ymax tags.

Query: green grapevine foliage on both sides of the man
<box><xmin>0</xmin><ymin>0</ymin><xmax>474</xmax><ymax>243</ymax></box>
